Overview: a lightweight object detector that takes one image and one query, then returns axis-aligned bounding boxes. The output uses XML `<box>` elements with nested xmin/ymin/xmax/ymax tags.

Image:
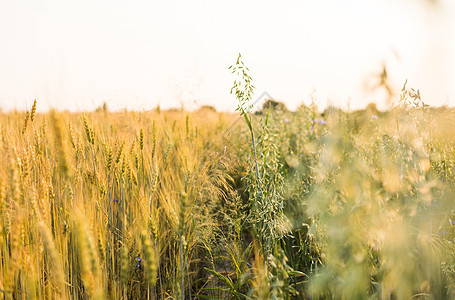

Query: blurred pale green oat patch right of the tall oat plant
<box><xmin>258</xmin><ymin>100</ymin><xmax>455</xmax><ymax>299</ymax></box>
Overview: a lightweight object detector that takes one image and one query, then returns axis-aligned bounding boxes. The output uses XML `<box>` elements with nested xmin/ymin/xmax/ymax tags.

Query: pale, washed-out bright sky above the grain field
<box><xmin>0</xmin><ymin>0</ymin><xmax>455</xmax><ymax>111</ymax></box>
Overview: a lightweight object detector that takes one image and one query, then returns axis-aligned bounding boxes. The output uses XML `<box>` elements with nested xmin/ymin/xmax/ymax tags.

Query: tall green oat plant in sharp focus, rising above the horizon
<box><xmin>207</xmin><ymin>54</ymin><xmax>302</xmax><ymax>299</ymax></box>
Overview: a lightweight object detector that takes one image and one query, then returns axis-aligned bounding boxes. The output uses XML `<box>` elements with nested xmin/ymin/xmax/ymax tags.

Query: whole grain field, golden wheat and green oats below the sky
<box><xmin>0</xmin><ymin>91</ymin><xmax>455</xmax><ymax>299</ymax></box>
